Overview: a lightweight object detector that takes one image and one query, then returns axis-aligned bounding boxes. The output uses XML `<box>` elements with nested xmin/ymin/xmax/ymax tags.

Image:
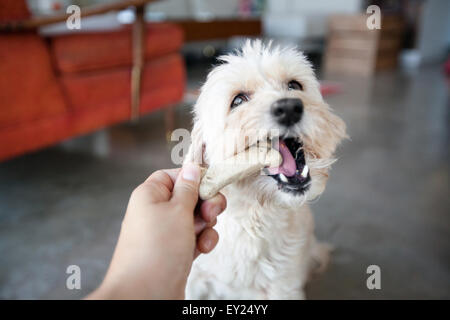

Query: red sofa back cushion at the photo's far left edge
<box><xmin>0</xmin><ymin>33</ymin><xmax>66</xmax><ymax>127</ymax></box>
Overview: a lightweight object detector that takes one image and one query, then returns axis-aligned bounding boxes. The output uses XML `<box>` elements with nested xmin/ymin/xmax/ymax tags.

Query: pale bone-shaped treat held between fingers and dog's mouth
<box><xmin>199</xmin><ymin>144</ymin><xmax>282</xmax><ymax>200</ymax></box>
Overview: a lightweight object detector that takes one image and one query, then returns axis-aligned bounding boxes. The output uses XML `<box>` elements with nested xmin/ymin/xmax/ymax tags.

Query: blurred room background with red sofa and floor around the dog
<box><xmin>0</xmin><ymin>0</ymin><xmax>450</xmax><ymax>299</ymax></box>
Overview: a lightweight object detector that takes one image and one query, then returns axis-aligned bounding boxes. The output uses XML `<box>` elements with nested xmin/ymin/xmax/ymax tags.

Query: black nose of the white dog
<box><xmin>270</xmin><ymin>98</ymin><xmax>303</xmax><ymax>127</ymax></box>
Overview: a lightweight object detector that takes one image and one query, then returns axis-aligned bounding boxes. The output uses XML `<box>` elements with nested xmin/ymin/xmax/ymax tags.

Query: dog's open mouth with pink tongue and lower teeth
<box><xmin>266</xmin><ymin>138</ymin><xmax>311</xmax><ymax>194</ymax></box>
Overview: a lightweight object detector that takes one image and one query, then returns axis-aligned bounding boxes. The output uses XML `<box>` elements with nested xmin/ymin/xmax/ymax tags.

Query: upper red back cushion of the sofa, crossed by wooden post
<box><xmin>51</xmin><ymin>23</ymin><xmax>183</xmax><ymax>73</ymax></box>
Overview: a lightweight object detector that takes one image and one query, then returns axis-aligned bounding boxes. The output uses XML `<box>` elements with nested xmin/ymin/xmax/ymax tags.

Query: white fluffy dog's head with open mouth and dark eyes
<box><xmin>188</xmin><ymin>41</ymin><xmax>346</xmax><ymax>202</ymax></box>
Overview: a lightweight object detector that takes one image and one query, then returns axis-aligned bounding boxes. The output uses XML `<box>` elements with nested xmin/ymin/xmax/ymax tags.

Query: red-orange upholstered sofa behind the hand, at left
<box><xmin>0</xmin><ymin>0</ymin><xmax>185</xmax><ymax>161</ymax></box>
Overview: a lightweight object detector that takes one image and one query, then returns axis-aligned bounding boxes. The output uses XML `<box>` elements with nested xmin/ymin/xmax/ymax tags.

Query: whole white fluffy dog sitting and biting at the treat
<box><xmin>186</xmin><ymin>40</ymin><xmax>346</xmax><ymax>299</ymax></box>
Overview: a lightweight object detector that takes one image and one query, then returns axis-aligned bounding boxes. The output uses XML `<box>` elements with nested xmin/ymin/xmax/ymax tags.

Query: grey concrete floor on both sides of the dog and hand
<box><xmin>0</xmin><ymin>63</ymin><xmax>450</xmax><ymax>299</ymax></box>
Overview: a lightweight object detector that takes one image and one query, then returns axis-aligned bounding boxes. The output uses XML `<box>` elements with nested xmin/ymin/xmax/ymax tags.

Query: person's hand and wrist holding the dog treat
<box><xmin>86</xmin><ymin>164</ymin><xmax>226</xmax><ymax>299</ymax></box>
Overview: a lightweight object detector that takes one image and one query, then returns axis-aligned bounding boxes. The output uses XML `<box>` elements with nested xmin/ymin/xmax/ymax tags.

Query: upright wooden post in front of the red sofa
<box><xmin>130</xmin><ymin>6</ymin><xmax>145</xmax><ymax>120</ymax></box>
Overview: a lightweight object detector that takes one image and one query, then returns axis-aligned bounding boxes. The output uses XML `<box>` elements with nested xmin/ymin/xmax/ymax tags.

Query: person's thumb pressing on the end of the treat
<box><xmin>172</xmin><ymin>163</ymin><xmax>200</xmax><ymax>212</ymax></box>
